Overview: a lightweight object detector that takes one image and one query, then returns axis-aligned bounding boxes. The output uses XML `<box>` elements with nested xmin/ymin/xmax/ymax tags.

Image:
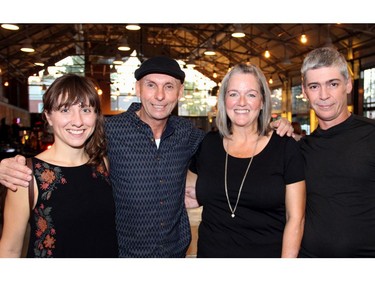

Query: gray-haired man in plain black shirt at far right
<box><xmin>300</xmin><ymin>47</ymin><xmax>375</xmax><ymax>258</ymax></box>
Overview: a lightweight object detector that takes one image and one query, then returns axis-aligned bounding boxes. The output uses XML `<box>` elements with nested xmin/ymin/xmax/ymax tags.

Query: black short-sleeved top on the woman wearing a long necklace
<box><xmin>190</xmin><ymin>132</ymin><xmax>304</xmax><ymax>258</ymax></box>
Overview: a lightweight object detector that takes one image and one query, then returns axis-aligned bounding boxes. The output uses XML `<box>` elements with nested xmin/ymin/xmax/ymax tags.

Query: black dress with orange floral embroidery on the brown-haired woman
<box><xmin>27</xmin><ymin>158</ymin><xmax>118</xmax><ymax>258</ymax></box>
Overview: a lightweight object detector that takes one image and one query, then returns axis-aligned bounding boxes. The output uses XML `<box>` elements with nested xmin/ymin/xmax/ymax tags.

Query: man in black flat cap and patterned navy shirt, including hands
<box><xmin>0</xmin><ymin>56</ymin><xmax>292</xmax><ymax>258</ymax></box>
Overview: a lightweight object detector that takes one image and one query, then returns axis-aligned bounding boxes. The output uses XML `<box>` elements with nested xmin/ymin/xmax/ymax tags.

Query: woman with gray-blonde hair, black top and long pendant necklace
<box><xmin>187</xmin><ymin>64</ymin><xmax>306</xmax><ymax>258</ymax></box>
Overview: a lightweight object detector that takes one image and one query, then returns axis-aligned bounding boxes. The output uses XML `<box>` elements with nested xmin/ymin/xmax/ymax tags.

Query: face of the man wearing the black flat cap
<box><xmin>136</xmin><ymin>73</ymin><xmax>184</xmax><ymax>124</ymax></box>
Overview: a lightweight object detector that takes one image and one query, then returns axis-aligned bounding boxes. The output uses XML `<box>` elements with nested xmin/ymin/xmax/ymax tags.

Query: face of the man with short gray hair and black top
<box><xmin>303</xmin><ymin>66</ymin><xmax>352</xmax><ymax>129</ymax></box>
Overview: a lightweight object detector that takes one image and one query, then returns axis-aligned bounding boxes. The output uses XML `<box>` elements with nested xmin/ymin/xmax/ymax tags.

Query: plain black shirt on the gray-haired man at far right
<box><xmin>300</xmin><ymin>115</ymin><xmax>375</xmax><ymax>258</ymax></box>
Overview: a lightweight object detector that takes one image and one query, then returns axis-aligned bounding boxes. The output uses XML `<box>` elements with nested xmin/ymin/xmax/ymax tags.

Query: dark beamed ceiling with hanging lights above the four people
<box><xmin>0</xmin><ymin>23</ymin><xmax>375</xmax><ymax>85</ymax></box>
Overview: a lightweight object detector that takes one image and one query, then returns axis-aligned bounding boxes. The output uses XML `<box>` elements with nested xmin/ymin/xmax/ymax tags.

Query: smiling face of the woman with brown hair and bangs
<box><xmin>44</xmin><ymin>95</ymin><xmax>97</xmax><ymax>148</ymax></box>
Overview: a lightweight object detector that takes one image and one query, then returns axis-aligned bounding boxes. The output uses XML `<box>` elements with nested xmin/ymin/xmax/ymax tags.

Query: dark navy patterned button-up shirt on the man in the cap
<box><xmin>106</xmin><ymin>103</ymin><xmax>205</xmax><ymax>258</ymax></box>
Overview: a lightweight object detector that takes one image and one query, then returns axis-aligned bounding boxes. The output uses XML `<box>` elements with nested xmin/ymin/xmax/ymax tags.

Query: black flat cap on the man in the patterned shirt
<box><xmin>134</xmin><ymin>56</ymin><xmax>185</xmax><ymax>83</ymax></box>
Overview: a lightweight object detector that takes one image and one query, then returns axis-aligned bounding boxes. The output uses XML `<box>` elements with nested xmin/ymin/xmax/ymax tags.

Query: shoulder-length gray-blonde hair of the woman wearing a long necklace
<box><xmin>216</xmin><ymin>63</ymin><xmax>272</xmax><ymax>137</ymax></box>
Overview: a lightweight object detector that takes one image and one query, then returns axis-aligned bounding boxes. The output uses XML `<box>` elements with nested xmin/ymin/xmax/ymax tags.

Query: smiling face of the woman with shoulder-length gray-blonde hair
<box><xmin>225</xmin><ymin>73</ymin><xmax>263</xmax><ymax>130</ymax></box>
